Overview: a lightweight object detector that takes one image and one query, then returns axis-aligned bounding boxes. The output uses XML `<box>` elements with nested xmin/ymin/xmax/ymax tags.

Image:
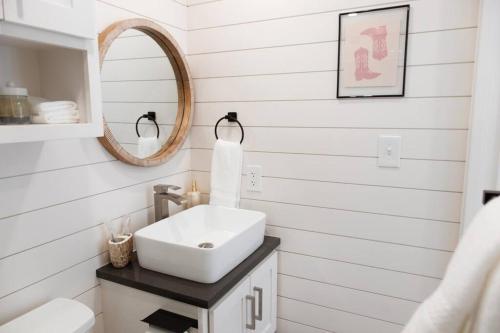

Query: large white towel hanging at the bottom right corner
<box><xmin>402</xmin><ymin>199</ymin><xmax>500</xmax><ymax>333</ymax></box>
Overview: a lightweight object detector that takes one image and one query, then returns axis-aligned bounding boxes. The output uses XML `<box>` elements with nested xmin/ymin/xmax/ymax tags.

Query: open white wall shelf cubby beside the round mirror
<box><xmin>0</xmin><ymin>11</ymin><xmax>103</xmax><ymax>144</ymax></box>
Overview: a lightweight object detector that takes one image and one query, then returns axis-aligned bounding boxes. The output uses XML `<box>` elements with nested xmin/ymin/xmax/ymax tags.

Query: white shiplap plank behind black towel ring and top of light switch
<box><xmin>191</xmin><ymin>126</ymin><xmax>467</xmax><ymax>161</ymax></box>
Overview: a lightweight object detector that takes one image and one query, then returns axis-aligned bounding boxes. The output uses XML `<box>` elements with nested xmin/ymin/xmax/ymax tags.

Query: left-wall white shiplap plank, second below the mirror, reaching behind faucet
<box><xmin>0</xmin><ymin>172</ymin><xmax>189</xmax><ymax>258</ymax></box>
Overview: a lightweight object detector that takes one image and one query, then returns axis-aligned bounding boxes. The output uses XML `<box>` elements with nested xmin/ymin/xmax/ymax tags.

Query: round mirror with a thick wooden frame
<box><xmin>99</xmin><ymin>19</ymin><xmax>193</xmax><ymax>166</ymax></box>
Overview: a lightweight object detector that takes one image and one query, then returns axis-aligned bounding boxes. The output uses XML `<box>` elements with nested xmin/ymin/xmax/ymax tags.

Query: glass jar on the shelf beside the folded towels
<box><xmin>0</xmin><ymin>82</ymin><xmax>31</xmax><ymax>125</ymax></box>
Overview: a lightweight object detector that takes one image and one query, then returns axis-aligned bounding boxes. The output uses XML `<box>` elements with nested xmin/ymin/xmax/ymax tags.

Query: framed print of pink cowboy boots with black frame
<box><xmin>337</xmin><ymin>5</ymin><xmax>410</xmax><ymax>98</ymax></box>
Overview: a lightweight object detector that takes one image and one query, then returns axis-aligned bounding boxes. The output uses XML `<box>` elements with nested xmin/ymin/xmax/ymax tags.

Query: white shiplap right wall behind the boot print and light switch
<box><xmin>188</xmin><ymin>0</ymin><xmax>478</xmax><ymax>333</ymax></box>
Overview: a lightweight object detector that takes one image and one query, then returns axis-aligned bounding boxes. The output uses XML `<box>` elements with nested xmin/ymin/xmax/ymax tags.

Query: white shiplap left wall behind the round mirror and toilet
<box><xmin>0</xmin><ymin>0</ymin><xmax>190</xmax><ymax>332</ymax></box>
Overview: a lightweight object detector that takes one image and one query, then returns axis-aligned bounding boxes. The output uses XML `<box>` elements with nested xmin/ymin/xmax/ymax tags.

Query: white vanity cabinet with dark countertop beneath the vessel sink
<box><xmin>97</xmin><ymin>241</ymin><xmax>279</xmax><ymax>333</ymax></box>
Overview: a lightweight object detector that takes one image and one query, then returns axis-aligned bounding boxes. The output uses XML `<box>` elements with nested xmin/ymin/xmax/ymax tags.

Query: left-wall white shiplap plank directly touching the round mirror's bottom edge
<box><xmin>0</xmin><ymin>150</ymin><xmax>190</xmax><ymax>218</ymax></box>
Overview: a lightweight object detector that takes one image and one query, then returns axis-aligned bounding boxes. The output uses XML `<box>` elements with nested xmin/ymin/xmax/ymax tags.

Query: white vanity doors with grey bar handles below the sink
<box><xmin>209</xmin><ymin>253</ymin><xmax>277</xmax><ymax>333</ymax></box>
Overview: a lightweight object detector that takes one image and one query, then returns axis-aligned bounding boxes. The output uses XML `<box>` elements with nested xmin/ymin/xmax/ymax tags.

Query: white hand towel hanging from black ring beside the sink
<box><xmin>210</xmin><ymin>140</ymin><xmax>243</xmax><ymax>208</ymax></box>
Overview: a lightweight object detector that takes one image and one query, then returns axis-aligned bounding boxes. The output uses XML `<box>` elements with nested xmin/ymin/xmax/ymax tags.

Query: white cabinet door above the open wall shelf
<box><xmin>3</xmin><ymin>0</ymin><xmax>96</xmax><ymax>39</ymax></box>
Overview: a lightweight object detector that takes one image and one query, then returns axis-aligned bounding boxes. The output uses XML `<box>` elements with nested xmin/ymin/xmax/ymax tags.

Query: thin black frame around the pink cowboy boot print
<box><xmin>336</xmin><ymin>5</ymin><xmax>410</xmax><ymax>99</ymax></box>
